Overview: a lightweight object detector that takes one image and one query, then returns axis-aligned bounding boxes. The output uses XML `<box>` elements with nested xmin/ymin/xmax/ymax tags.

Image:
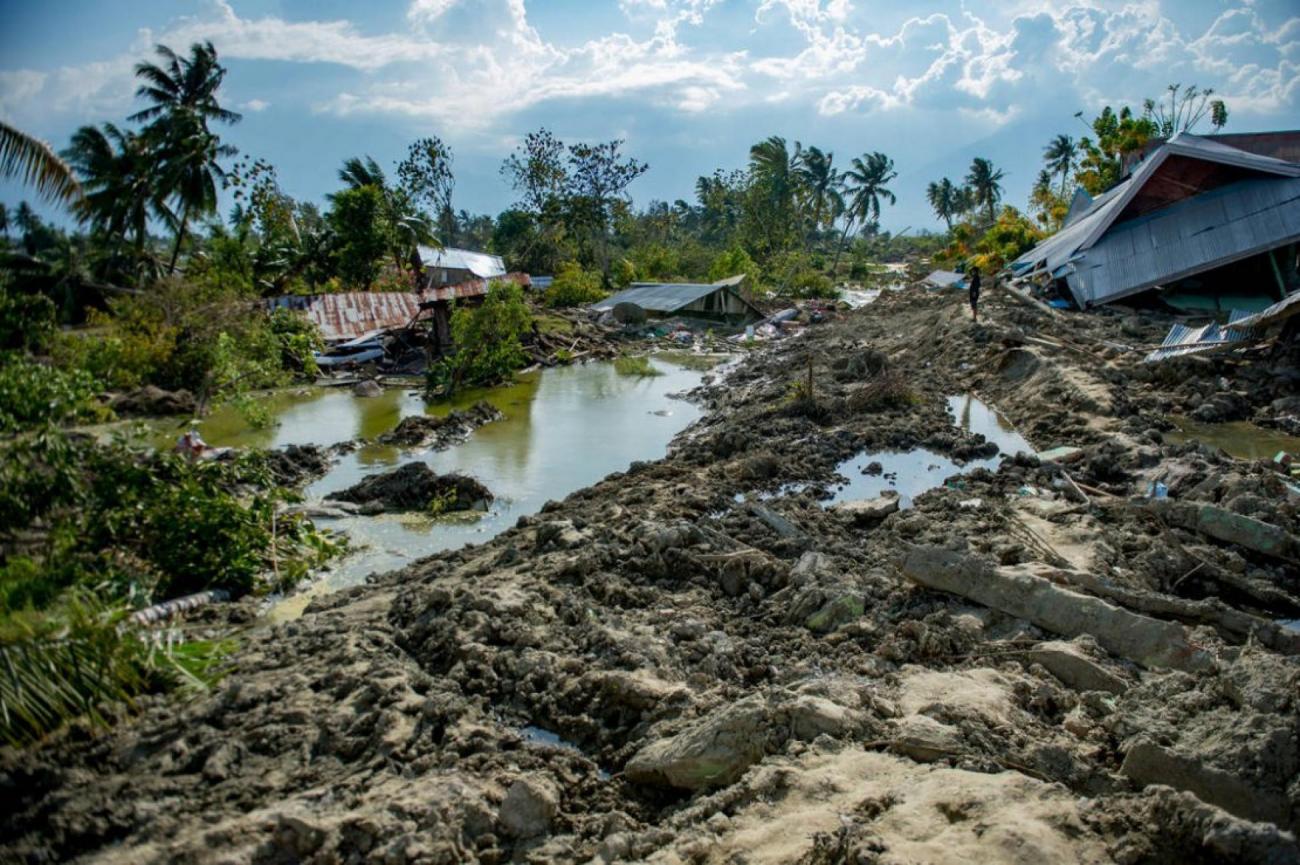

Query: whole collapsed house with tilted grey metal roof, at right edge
<box><xmin>1009</xmin><ymin>133</ymin><xmax>1300</xmax><ymax>312</ymax></box>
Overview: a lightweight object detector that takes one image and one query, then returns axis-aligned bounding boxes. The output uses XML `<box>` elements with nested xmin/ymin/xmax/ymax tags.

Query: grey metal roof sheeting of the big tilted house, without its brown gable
<box><xmin>1009</xmin><ymin>133</ymin><xmax>1300</xmax><ymax>307</ymax></box>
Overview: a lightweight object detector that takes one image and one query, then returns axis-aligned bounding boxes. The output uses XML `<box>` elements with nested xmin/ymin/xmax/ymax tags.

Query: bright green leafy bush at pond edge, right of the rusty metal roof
<box><xmin>426</xmin><ymin>281</ymin><xmax>533</xmax><ymax>393</ymax></box>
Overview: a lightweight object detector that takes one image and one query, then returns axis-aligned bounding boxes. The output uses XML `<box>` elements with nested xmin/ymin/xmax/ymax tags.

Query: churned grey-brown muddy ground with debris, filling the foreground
<box><xmin>0</xmin><ymin>291</ymin><xmax>1300</xmax><ymax>864</ymax></box>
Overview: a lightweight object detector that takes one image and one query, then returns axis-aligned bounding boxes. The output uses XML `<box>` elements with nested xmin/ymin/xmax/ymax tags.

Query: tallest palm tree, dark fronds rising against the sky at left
<box><xmin>130</xmin><ymin>42</ymin><xmax>242</xmax><ymax>272</ymax></box>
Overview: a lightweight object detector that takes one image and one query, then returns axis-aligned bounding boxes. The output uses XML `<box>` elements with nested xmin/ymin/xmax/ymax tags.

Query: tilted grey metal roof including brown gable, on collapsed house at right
<box><xmin>1010</xmin><ymin>133</ymin><xmax>1300</xmax><ymax>307</ymax></box>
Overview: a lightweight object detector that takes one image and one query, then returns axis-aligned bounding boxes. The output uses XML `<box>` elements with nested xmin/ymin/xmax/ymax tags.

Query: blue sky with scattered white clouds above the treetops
<box><xmin>0</xmin><ymin>0</ymin><xmax>1300</xmax><ymax>232</ymax></box>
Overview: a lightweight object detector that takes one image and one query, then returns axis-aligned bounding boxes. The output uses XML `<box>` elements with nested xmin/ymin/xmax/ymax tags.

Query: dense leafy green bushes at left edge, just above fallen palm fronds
<box><xmin>0</xmin><ymin>432</ymin><xmax>337</xmax><ymax>609</ymax></box>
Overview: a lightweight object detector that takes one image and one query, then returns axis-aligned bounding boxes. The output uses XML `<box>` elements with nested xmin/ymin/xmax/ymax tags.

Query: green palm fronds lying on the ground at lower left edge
<box><xmin>0</xmin><ymin>589</ymin><xmax>229</xmax><ymax>745</ymax></box>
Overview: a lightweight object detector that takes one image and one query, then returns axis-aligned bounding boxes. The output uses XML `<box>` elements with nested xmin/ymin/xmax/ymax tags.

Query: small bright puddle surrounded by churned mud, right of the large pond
<box><xmin>826</xmin><ymin>395</ymin><xmax>1034</xmax><ymax>509</ymax></box>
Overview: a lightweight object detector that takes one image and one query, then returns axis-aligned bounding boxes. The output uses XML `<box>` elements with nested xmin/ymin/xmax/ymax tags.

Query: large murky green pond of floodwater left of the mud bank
<box><xmin>231</xmin><ymin>358</ymin><xmax>716</xmax><ymax>619</ymax></box>
